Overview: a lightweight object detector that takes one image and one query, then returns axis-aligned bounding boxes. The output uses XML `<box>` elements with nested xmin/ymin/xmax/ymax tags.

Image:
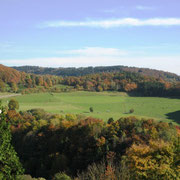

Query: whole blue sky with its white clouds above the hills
<box><xmin>0</xmin><ymin>0</ymin><xmax>180</xmax><ymax>74</ymax></box>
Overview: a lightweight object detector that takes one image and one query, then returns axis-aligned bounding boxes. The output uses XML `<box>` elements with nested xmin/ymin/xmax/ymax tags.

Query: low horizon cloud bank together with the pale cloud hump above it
<box><xmin>0</xmin><ymin>45</ymin><xmax>180</xmax><ymax>74</ymax></box>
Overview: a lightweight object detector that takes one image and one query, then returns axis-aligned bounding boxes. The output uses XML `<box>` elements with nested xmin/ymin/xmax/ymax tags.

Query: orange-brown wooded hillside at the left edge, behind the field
<box><xmin>0</xmin><ymin>64</ymin><xmax>62</xmax><ymax>92</ymax></box>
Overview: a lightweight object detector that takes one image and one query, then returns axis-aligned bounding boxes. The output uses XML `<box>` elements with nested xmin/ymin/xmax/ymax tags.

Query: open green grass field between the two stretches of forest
<box><xmin>2</xmin><ymin>92</ymin><xmax>180</xmax><ymax>124</ymax></box>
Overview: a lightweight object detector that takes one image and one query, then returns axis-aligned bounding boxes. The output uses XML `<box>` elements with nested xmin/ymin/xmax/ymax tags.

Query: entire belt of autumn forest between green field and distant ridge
<box><xmin>0</xmin><ymin>65</ymin><xmax>180</xmax><ymax>96</ymax></box>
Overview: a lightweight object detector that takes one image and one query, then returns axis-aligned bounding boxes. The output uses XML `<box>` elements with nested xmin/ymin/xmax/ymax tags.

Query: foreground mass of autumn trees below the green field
<box><xmin>0</xmin><ymin>99</ymin><xmax>180</xmax><ymax>180</ymax></box>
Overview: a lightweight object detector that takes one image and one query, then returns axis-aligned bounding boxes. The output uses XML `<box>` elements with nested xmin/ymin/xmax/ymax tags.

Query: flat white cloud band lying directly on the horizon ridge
<box><xmin>0</xmin><ymin>56</ymin><xmax>180</xmax><ymax>75</ymax></box>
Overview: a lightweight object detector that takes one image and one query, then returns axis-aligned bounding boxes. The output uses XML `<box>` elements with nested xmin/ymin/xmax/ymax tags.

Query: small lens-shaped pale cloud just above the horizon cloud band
<box><xmin>57</xmin><ymin>47</ymin><xmax>128</xmax><ymax>56</ymax></box>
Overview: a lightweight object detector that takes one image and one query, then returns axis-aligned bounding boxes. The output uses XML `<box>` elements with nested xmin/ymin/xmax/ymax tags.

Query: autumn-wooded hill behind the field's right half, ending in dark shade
<box><xmin>62</xmin><ymin>72</ymin><xmax>180</xmax><ymax>96</ymax></box>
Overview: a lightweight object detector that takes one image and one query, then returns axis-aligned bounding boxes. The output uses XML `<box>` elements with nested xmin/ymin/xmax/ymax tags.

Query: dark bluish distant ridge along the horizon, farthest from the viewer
<box><xmin>12</xmin><ymin>66</ymin><xmax>180</xmax><ymax>82</ymax></box>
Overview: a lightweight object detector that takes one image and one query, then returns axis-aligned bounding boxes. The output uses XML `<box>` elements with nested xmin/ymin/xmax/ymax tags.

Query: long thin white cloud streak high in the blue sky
<box><xmin>38</xmin><ymin>18</ymin><xmax>180</xmax><ymax>28</ymax></box>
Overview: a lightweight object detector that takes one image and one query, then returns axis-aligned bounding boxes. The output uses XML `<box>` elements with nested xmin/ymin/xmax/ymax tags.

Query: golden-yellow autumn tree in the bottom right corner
<box><xmin>122</xmin><ymin>140</ymin><xmax>180</xmax><ymax>180</ymax></box>
